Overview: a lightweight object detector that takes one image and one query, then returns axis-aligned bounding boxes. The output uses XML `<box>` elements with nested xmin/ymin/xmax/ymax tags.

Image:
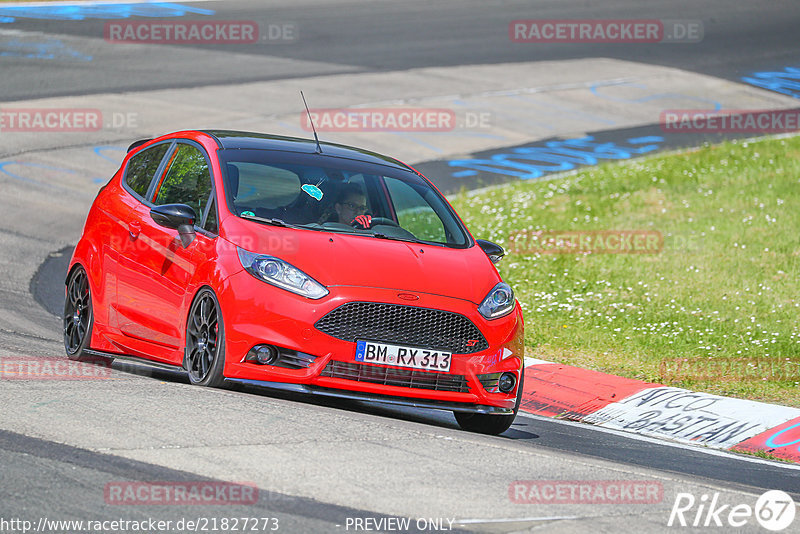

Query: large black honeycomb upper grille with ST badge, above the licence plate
<box><xmin>314</xmin><ymin>302</ymin><xmax>489</xmax><ymax>354</ymax></box>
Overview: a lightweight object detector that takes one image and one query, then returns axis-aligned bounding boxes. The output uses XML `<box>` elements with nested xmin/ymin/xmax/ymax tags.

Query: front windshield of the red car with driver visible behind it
<box><xmin>219</xmin><ymin>149</ymin><xmax>469</xmax><ymax>247</ymax></box>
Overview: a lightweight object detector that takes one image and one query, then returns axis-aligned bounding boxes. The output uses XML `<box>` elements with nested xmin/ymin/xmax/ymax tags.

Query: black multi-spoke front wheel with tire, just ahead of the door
<box><xmin>183</xmin><ymin>287</ymin><xmax>225</xmax><ymax>388</ymax></box>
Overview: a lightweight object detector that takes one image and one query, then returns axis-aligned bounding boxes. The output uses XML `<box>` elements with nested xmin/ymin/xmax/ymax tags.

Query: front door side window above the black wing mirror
<box><xmin>155</xmin><ymin>144</ymin><xmax>211</xmax><ymax>224</ymax></box>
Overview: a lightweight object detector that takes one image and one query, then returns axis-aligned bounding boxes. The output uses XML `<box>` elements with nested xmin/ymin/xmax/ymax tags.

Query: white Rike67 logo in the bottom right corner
<box><xmin>667</xmin><ymin>490</ymin><xmax>797</xmax><ymax>532</ymax></box>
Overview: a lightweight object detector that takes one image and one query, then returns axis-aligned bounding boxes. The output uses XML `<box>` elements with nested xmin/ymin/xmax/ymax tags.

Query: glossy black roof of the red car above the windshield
<box><xmin>201</xmin><ymin>130</ymin><xmax>416</xmax><ymax>174</ymax></box>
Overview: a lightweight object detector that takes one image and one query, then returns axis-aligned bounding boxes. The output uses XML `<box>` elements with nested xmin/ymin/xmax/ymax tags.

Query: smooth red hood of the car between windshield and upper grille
<box><xmin>225</xmin><ymin>219</ymin><xmax>501</xmax><ymax>304</ymax></box>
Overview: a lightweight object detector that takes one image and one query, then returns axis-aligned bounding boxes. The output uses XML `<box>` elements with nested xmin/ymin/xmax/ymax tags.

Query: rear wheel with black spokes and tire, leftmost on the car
<box><xmin>63</xmin><ymin>265</ymin><xmax>96</xmax><ymax>361</ymax></box>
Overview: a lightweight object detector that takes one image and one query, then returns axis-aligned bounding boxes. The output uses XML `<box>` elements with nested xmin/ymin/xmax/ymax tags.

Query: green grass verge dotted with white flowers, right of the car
<box><xmin>453</xmin><ymin>137</ymin><xmax>800</xmax><ymax>407</ymax></box>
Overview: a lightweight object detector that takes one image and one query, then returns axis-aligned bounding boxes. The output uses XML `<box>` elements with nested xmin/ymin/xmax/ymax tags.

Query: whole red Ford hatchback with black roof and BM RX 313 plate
<box><xmin>64</xmin><ymin>131</ymin><xmax>524</xmax><ymax>434</ymax></box>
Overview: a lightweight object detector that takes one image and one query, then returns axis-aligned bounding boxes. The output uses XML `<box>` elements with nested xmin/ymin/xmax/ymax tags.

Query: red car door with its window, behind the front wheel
<box><xmin>117</xmin><ymin>141</ymin><xmax>216</xmax><ymax>363</ymax></box>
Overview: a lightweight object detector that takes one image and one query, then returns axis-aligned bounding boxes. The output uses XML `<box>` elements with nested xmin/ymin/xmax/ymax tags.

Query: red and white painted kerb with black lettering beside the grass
<box><xmin>520</xmin><ymin>358</ymin><xmax>800</xmax><ymax>461</ymax></box>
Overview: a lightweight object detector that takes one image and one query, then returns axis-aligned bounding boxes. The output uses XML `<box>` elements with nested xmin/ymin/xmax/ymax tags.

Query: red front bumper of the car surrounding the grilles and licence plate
<box><xmin>220</xmin><ymin>272</ymin><xmax>524</xmax><ymax>414</ymax></box>
